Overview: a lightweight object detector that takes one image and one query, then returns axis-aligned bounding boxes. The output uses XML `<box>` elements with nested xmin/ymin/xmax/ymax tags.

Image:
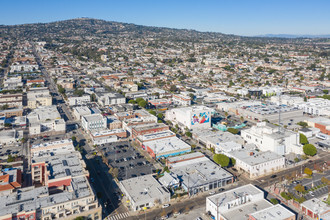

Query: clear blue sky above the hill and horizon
<box><xmin>0</xmin><ymin>0</ymin><xmax>330</xmax><ymax>35</ymax></box>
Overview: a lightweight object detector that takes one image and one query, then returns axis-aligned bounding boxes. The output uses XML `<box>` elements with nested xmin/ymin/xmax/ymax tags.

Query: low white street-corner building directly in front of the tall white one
<box><xmin>224</xmin><ymin>149</ymin><xmax>285</xmax><ymax>178</ymax></box>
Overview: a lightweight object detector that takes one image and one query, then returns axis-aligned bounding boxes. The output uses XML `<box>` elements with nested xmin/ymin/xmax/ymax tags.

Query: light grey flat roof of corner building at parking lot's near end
<box><xmin>120</xmin><ymin>174</ymin><xmax>169</xmax><ymax>202</ymax></box>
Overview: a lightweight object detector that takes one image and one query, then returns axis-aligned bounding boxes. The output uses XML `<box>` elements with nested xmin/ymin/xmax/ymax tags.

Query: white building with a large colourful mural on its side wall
<box><xmin>165</xmin><ymin>106</ymin><xmax>213</xmax><ymax>130</ymax></box>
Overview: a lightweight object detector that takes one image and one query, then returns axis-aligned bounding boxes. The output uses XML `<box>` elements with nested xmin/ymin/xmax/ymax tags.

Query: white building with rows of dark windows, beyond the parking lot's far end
<box><xmin>81</xmin><ymin>114</ymin><xmax>107</xmax><ymax>131</ymax></box>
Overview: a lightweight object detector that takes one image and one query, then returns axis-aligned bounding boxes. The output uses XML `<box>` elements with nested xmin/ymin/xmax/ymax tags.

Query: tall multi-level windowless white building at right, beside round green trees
<box><xmin>241</xmin><ymin>122</ymin><xmax>303</xmax><ymax>155</ymax></box>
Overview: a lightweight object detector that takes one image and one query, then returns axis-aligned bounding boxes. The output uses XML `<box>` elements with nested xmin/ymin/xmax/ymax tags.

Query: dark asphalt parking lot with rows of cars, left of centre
<box><xmin>98</xmin><ymin>141</ymin><xmax>156</xmax><ymax>181</ymax></box>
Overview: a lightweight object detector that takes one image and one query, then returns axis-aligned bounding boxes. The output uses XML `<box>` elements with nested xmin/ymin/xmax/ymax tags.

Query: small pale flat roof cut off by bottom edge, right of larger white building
<box><xmin>251</xmin><ymin>204</ymin><xmax>295</xmax><ymax>220</ymax></box>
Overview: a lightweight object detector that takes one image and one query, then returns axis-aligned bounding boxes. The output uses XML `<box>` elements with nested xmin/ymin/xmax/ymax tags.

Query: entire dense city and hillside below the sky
<box><xmin>0</xmin><ymin>18</ymin><xmax>330</xmax><ymax>220</ymax></box>
